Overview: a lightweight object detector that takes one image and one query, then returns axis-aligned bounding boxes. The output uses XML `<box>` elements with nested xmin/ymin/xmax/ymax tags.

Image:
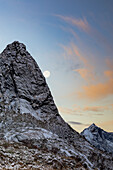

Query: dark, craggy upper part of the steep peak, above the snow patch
<box><xmin>0</xmin><ymin>41</ymin><xmax>51</xmax><ymax>105</ymax></box>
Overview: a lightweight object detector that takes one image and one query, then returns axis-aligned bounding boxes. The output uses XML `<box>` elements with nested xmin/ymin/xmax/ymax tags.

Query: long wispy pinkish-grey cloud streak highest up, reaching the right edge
<box><xmin>54</xmin><ymin>14</ymin><xmax>113</xmax><ymax>54</ymax></box>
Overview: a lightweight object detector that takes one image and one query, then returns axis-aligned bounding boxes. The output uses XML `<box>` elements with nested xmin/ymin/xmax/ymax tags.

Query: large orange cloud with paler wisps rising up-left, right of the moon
<box><xmin>62</xmin><ymin>43</ymin><xmax>113</xmax><ymax>100</ymax></box>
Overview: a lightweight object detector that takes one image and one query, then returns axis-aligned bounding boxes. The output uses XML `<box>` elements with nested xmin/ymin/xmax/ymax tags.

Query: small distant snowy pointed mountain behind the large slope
<box><xmin>81</xmin><ymin>124</ymin><xmax>113</xmax><ymax>153</ymax></box>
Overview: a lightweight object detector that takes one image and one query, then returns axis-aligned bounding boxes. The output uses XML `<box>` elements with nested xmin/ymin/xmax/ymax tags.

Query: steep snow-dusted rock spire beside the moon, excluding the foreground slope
<box><xmin>0</xmin><ymin>41</ymin><xmax>78</xmax><ymax>142</ymax></box>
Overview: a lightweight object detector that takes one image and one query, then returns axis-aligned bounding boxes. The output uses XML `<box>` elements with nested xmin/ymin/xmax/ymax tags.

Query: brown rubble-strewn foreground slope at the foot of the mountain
<box><xmin>0</xmin><ymin>140</ymin><xmax>91</xmax><ymax>170</ymax></box>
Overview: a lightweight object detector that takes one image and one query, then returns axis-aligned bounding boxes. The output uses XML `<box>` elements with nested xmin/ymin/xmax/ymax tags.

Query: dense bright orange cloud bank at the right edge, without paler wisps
<box><xmin>78</xmin><ymin>60</ymin><xmax>113</xmax><ymax>100</ymax></box>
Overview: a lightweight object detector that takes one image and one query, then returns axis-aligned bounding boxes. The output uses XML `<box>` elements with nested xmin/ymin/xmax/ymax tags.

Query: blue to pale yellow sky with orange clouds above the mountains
<box><xmin>0</xmin><ymin>0</ymin><xmax>113</xmax><ymax>132</ymax></box>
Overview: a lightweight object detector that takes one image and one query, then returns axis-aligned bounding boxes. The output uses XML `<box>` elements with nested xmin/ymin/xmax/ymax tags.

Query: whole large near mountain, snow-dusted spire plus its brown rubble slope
<box><xmin>0</xmin><ymin>41</ymin><xmax>113</xmax><ymax>170</ymax></box>
